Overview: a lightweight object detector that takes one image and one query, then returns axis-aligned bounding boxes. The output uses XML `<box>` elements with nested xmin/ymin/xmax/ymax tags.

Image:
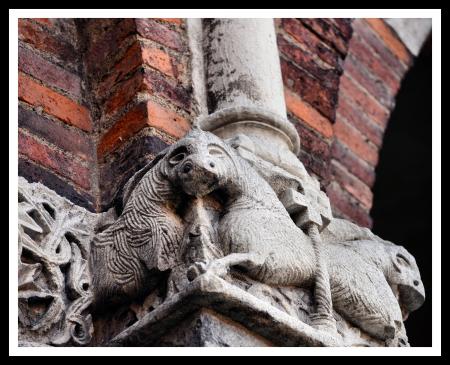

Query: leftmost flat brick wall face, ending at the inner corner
<box><xmin>19</xmin><ymin>19</ymin><xmax>95</xmax><ymax>210</ymax></box>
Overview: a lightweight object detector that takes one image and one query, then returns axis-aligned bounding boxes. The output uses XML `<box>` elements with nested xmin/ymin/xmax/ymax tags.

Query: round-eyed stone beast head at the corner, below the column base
<box><xmin>164</xmin><ymin>129</ymin><xmax>236</xmax><ymax>197</ymax></box>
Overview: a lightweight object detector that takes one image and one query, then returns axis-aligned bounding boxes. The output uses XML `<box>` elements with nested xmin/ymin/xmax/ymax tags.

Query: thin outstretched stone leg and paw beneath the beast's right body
<box><xmin>187</xmin><ymin>253</ymin><xmax>266</xmax><ymax>281</ymax></box>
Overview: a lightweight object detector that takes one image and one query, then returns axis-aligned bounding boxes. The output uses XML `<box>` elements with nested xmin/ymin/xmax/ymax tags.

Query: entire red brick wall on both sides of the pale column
<box><xmin>19</xmin><ymin>19</ymin><xmax>418</xmax><ymax>226</ymax></box>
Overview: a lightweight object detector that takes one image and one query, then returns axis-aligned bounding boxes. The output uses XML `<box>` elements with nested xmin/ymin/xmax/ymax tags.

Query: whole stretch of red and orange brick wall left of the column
<box><xmin>19</xmin><ymin>19</ymin><xmax>192</xmax><ymax>211</ymax></box>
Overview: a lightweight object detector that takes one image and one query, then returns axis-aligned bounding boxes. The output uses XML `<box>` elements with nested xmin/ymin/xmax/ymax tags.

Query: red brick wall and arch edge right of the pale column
<box><xmin>276</xmin><ymin>19</ymin><xmax>412</xmax><ymax>227</ymax></box>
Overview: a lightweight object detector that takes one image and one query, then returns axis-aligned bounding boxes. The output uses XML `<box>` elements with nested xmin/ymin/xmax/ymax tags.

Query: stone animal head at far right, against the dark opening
<box><xmin>386</xmin><ymin>244</ymin><xmax>425</xmax><ymax>320</ymax></box>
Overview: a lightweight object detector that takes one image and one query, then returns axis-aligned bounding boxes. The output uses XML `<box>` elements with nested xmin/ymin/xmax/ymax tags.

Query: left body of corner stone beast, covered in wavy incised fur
<box><xmin>90</xmin><ymin>132</ymin><xmax>216</xmax><ymax>304</ymax></box>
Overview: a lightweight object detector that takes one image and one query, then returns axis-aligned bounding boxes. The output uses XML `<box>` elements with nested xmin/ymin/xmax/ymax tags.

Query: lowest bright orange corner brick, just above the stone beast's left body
<box><xmin>97</xmin><ymin>100</ymin><xmax>190</xmax><ymax>158</ymax></box>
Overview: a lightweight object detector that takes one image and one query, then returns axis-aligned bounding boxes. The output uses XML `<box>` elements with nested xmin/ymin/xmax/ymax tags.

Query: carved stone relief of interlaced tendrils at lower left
<box><xmin>18</xmin><ymin>178</ymin><xmax>95</xmax><ymax>345</ymax></box>
